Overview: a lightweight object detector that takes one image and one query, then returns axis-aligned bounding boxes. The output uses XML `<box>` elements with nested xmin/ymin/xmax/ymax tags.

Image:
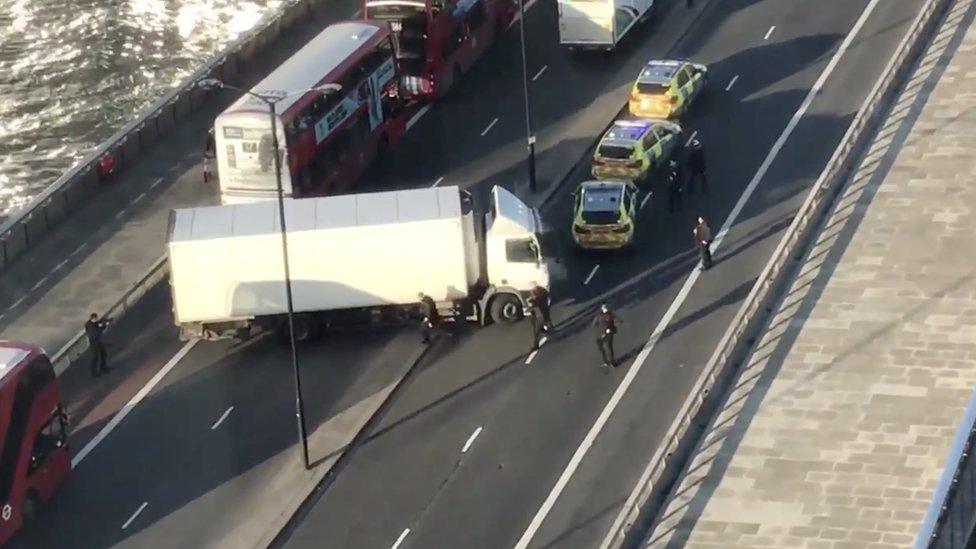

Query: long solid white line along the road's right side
<box><xmin>514</xmin><ymin>0</ymin><xmax>878</xmax><ymax>549</ymax></box>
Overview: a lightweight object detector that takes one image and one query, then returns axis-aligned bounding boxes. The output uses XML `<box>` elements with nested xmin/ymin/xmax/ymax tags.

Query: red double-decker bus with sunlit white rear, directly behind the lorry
<box><xmin>214</xmin><ymin>21</ymin><xmax>410</xmax><ymax>204</ymax></box>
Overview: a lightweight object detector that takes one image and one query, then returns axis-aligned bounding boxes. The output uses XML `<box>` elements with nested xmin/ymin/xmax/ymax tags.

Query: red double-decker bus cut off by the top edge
<box><xmin>363</xmin><ymin>0</ymin><xmax>516</xmax><ymax>100</ymax></box>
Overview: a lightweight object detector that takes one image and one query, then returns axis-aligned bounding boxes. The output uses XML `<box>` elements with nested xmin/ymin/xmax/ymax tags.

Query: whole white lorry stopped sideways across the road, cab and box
<box><xmin>168</xmin><ymin>187</ymin><xmax>549</xmax><ymax>340</ymax></box>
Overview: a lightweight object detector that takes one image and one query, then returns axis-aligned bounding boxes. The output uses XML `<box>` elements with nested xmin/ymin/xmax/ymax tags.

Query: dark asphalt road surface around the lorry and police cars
<box><xmin>5</xmin><ymin>0</ymin><xmax>916</xmax><ymax>547</ymax></box>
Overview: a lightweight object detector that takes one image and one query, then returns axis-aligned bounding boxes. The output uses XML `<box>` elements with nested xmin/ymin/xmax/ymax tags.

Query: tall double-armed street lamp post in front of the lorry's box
<box><xmin>197</xmin><ymin>78</ymin><xmax>342</xmax><ymax>469</ymax></box>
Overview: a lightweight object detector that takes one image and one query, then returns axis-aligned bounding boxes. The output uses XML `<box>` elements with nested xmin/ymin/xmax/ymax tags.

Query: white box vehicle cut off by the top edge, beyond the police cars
<box><xmin>557</xmin><ymin>0</ymin><xmax>654</xmax><ymax>51</ymax></box>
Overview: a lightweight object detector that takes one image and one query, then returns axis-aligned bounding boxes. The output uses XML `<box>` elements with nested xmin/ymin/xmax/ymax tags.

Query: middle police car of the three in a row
<box><xmin>591</xmin><ymin>119</ymin><xmax>681</xmax><ymax>181</ymax></box>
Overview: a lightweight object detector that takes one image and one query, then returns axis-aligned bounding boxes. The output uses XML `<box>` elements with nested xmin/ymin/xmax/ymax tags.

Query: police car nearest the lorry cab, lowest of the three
<box><xmin>573</xmin><ymin>180</ymin><xmax>637</xmax><ymax>249</ymax></box>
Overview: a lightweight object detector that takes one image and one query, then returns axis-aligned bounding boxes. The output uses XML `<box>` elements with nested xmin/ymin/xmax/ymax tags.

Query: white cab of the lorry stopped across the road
<box><xmin>485</xmin><ymin>186</ymin><xmax>549</xmax><ymax>321</ymax></box>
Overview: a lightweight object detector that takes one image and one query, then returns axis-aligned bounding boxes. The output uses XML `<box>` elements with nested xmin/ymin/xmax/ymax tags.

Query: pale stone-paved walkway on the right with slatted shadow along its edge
<box><xmin>648</xmin><ymin>0</ymin><xmax>976</xmax><ymax>549</ymax></box>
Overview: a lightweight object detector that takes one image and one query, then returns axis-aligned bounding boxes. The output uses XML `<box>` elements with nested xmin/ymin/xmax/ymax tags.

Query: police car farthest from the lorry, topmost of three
<box><xmin>628</xmin><ymin>60</ymin><xmax>708</xmax><ymax>118</ymax></box>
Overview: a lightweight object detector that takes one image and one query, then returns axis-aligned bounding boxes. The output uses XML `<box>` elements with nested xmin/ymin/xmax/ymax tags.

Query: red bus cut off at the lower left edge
<box><xmin>0</xmin><ymin>341</ymin><xmax>71</xmax><ymax>544</ymax></box>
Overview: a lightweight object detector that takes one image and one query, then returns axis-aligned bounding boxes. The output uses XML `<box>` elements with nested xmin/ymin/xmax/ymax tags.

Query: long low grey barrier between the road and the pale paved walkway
<box><xmin>601</xmin><ymin>0</ymin><xmax>950</xmax><ymax>549</ymax></box>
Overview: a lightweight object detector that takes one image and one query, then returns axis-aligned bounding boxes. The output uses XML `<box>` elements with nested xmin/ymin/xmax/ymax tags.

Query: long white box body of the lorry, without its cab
<box><xmin>169</xmin><ymin>187</ymin><xmax>479</xmax><ymax>324</ymax></box>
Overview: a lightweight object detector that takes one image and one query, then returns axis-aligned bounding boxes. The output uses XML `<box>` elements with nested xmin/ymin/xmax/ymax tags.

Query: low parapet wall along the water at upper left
<box><xmin>0</xmin><ymin>0</ymin><xmax>325</xmax><ymax>271</ymax></box>
